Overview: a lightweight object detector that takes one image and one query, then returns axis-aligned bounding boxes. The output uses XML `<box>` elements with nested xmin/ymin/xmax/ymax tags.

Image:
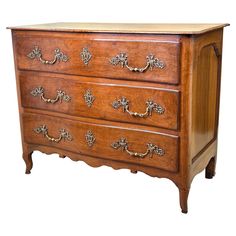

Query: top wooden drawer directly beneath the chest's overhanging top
<box><xmin>13</xmin><ymin>31</ymin><xmax>180</xmax><ymax>84</ymax></box>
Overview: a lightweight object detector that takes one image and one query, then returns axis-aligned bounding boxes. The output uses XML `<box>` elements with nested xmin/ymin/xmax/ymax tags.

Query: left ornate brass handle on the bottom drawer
<box><xmin>34</xmin><ymin>125</ymin><xmax>72</xmax><ymax>143</ymax></box>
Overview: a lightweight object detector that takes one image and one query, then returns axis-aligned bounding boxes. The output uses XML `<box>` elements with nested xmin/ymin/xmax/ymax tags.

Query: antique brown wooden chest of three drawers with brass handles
<box><xmin>8</xmin><ymin>23</ymin><xmax>227</xmax><ymax>213</ymax></box>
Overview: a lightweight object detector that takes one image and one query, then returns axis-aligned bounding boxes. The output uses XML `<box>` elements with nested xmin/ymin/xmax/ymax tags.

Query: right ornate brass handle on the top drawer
<box><xmin>110</xmin><ymin>52</ymin><xmax>165</xmax><ymax>73</ymax></box>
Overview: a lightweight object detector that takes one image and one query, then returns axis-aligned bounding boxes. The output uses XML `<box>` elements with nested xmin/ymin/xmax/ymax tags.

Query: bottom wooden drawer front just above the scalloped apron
<box><xmin>23</xmin><ymin>114</ymin><xmax>178</xmax><ymax>171</ymax></box>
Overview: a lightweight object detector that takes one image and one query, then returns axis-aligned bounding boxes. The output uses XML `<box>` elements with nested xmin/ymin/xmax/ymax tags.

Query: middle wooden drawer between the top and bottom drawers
<box><xmin>19</xmin><ymin>72</ymin><xmax>179</xmax><ymax>130</ymax></box>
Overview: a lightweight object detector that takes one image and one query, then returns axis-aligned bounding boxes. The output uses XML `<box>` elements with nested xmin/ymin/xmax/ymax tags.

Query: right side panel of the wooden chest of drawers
<box><xmin>190</xmin><ymin>30</ymin><xmax>222</xmax><ymax>162</ymax></box>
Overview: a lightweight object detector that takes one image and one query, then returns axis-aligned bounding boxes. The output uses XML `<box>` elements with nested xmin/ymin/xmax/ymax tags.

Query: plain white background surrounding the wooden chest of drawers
<box><xmin>0</xmin><ymin>0</ymin><xmax>236</xmax><ymax>236</ymax></box>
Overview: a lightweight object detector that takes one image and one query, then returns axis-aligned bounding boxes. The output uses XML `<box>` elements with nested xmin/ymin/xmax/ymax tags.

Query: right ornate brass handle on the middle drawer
<box><xmin>112</xmin><ymin>97</ymin><xmax>165</xmax><ymax>118</ymax></box>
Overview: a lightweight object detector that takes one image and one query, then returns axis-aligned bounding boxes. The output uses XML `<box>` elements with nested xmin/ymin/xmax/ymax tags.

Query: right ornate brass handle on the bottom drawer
<box><xmin>111</xmin><ymin>138</ymin><xmax>165</xmax><ymax>158</ymax></box>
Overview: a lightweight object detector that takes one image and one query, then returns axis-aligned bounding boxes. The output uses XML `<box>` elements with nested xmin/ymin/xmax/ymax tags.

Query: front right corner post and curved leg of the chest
<box><xmin>178</xmin><ymin>36</ymin><xmax>193</xmax><ymax>213</ymax></box>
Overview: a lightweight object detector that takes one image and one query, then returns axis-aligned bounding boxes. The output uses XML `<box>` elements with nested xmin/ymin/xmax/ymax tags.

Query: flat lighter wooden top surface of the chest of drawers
<box><xmin>8</xmin><ymin>22</ymin><xmax>229</xmax><ymax>34</ymax></box>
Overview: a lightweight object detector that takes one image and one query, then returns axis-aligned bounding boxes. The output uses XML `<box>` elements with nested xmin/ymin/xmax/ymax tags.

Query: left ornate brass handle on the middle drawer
<box><xmin>31</xmin><ymin>86</ymin><xmax>71</xmax><ymax>104</ymax></box>
